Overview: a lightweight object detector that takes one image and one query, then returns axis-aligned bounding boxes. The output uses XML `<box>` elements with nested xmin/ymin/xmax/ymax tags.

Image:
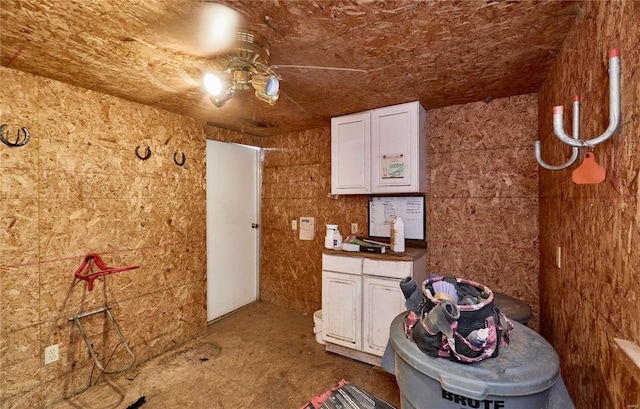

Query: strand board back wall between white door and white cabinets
<box><xmin>260</xmin><ymin>128</ymin><xmax>367</xmax><ymax>313</ymax></box>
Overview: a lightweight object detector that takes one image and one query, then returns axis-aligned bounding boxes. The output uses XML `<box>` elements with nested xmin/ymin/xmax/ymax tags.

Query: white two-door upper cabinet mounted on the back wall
<box><xmin>331</xmin><ymin>101</ymin><xmax>427</xmax><ymax>194</ymax></box>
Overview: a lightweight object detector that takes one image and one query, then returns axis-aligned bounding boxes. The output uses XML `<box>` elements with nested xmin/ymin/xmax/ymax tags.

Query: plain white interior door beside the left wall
<box><xmin>207</xmin><ymin>140</ymin><xmax>260</xmax><ymax>321</ymax></box>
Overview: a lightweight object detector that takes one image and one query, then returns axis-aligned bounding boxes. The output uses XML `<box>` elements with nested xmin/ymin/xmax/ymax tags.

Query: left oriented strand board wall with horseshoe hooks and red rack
<box><xmin>0</xmin><ymin>68</ymin><xmax>206</xmax><ymax>408</ymax></box>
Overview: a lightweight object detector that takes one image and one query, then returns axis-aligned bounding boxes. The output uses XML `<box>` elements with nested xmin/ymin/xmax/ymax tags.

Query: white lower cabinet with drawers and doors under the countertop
<box><xmin>322</xmin><ymin>251</ymin><xmax>427</xmax><ymax>365</ymax></box>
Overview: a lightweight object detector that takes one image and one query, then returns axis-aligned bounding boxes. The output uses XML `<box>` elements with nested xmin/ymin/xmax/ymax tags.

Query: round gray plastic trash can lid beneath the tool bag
<box><xmin>389</xmin><ymin>312</ymin><xmax>560</xmax><ymax>399</ymax></box>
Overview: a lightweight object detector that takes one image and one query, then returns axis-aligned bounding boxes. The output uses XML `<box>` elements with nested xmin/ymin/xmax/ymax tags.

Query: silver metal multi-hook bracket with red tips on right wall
<box><xmin>535</xmin><ymin>48</ymin><xmax>620</xmax><ymax>170</ymax></box>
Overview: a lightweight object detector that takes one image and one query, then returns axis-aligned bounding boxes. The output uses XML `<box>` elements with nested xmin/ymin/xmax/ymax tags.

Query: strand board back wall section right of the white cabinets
<box><xmin>427</xmin><ymin>94</ymin><xmax>539</xmax><ymax>329</ymax></box>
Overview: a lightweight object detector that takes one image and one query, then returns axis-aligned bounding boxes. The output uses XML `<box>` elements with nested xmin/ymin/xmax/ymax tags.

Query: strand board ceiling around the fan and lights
<box><xmin>0</xmin><ymin>0</ymin><xmax>580</xmax><ymax>136</ymax></box>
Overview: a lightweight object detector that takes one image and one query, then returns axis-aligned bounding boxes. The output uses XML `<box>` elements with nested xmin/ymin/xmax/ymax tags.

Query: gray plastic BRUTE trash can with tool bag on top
<box><xmin>385</xmin><ymin>312</ymin><xmax>574</xmax><ymax>409</ymax></box>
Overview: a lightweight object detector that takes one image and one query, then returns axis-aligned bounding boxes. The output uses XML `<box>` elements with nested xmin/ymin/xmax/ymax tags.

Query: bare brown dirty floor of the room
<box><xmin>54</xmin><ymin>302</ymin><xmax>400</xmax><ymax>409</ymax></box>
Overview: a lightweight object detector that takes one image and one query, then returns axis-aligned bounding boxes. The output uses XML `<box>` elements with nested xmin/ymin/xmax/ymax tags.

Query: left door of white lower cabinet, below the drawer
<box><xmin>322</xmin><ymin>271</ymin><xmax>362</xmax><ymax>350</ymax></box>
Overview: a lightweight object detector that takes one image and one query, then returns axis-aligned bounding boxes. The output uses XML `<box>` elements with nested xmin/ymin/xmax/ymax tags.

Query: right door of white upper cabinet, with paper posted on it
<box><xmin>371</xmin><ymin>102</ymin><xmax>426</xmax><ymax>193</ymax></box>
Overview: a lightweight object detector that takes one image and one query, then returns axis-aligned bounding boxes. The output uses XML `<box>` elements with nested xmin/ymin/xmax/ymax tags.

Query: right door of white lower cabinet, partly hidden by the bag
<box><xmin>362</xmin><ymin>276</ymin><xmax>405</xmax><ymax>356</ymax></box>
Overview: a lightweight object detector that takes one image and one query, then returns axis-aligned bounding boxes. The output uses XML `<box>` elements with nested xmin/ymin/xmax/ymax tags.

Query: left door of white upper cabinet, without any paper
<box><xmin>331</xmin><ymin>111</ymin><xmax>371</xmax><ymax>194</ymax></box>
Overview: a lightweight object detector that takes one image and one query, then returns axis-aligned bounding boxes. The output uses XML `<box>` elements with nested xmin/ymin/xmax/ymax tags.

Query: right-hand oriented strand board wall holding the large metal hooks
<box><xmin>539</xmin><ymin>1</ymin><xmax>640</xmax><ymax>408</ymax></box>
